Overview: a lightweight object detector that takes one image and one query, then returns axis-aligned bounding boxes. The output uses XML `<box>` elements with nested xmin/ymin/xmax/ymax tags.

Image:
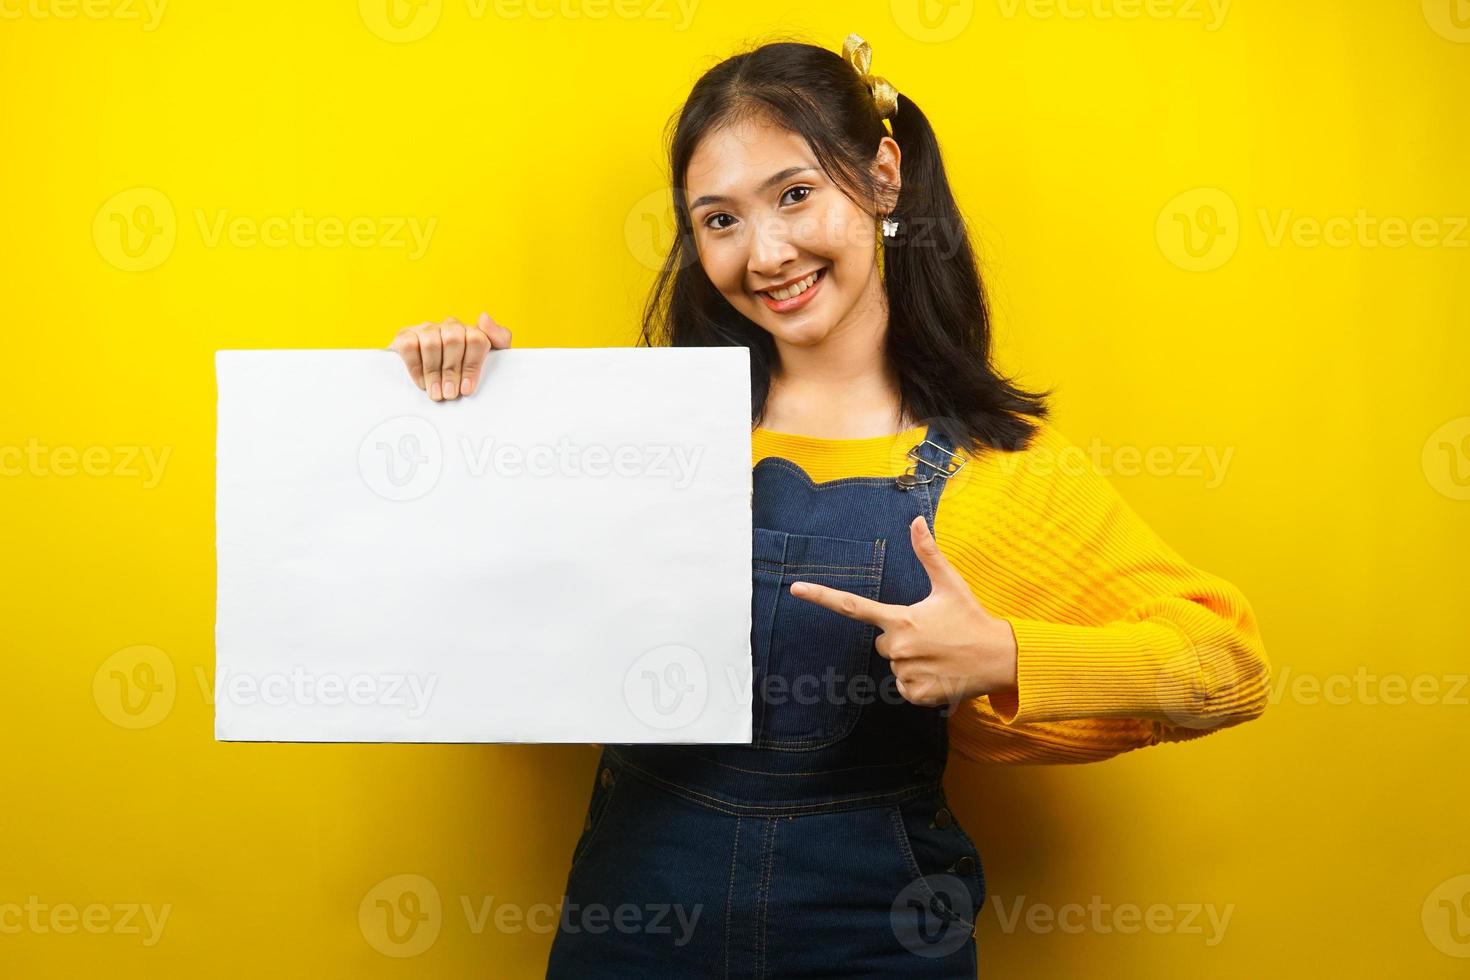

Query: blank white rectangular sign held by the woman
<box><xmin>215</xmin><ymin>347</ymin><xmax>751</xmax><ymax>743</ymax></box>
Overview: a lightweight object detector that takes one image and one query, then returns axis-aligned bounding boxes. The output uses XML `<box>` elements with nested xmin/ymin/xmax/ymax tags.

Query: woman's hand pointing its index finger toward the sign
<box><xmin>791</xmin><ymin>514</ymin><xmax>1016</xmax><ymax>705</ymax></box>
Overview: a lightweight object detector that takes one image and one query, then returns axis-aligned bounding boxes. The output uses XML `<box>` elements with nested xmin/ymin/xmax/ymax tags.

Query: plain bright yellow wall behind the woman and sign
<box><xmin>0</xmin><ymin>0</ymin><xmax>1470</xmax><ymax>977</ymax></box>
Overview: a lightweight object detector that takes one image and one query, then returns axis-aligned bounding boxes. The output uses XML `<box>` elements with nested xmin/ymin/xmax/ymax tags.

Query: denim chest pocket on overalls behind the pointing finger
<box><xmin>751</xmin><ymin>527</ymin><xmax>886</xmax><ymax>751</ymax></box>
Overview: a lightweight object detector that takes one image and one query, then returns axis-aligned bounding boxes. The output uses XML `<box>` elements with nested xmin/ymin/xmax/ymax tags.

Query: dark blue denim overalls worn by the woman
<box><xmin>547</xmin><ymin>426</ymin><xmax>985</xmax><ymax>979</ymax></box>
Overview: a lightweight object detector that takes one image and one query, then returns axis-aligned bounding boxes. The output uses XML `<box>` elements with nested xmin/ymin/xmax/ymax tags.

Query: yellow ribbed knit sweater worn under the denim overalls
<box><xmin>751</xmin><ymin>417</ymin><xmax>1269</xmax><ymax>763</ymax></box>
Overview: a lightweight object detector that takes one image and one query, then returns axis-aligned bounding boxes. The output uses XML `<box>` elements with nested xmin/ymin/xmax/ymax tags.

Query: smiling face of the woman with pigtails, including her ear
<box><xmin>685</xmin><ymin>119</ymin><xmax>898</xmax><ymax>347</ymax></box>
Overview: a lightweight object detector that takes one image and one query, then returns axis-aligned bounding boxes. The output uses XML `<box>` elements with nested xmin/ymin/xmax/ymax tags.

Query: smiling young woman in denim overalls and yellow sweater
<box><xmin>392</xmin><ymin>28</ymin><xmax>1267</xmax><ymax>977</ymax></box>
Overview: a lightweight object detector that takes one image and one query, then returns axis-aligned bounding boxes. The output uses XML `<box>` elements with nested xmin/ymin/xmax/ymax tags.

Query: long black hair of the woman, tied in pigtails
<box><xmin>639</xmin><ymin>34</ymin><xmax>1051</xmax><ymax>453</ymax></box>
